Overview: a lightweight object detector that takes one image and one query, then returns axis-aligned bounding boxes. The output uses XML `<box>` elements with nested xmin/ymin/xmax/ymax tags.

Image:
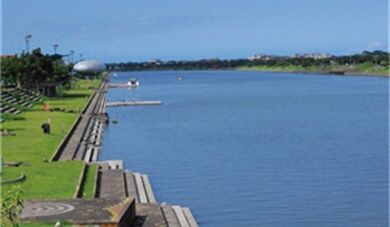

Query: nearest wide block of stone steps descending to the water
<box><xmin>90</xmin><ymin>160</ymin><xmax>198</xmax><ymax>227</ymax></box>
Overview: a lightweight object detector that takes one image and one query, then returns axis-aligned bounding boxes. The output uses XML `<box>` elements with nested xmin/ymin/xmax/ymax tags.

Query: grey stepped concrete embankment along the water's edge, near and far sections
<box><xmin>52</xmin><ymin>76</ymin><xmax>198</xmax><ymax>227</ymax></box>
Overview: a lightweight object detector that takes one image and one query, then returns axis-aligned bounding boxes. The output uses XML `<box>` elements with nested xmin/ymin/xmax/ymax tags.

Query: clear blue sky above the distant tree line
<box><xmin>1</xmin><ymin>0</ymin><xmax>389</xmax><ymax>63</ymax></box>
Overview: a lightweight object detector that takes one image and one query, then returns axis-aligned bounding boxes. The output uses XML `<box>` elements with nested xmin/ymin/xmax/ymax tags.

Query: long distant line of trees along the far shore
<box><xmin>107</xmin><ymin>50</ymin><xmax>389</xmax><ymax>71</ymax></box>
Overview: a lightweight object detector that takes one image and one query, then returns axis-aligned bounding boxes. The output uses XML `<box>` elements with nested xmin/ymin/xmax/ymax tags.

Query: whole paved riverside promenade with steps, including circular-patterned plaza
<box><xmin>21</xmin><ymin>77</ymin><xmax>198</xmax><ymax>227</ymax></box>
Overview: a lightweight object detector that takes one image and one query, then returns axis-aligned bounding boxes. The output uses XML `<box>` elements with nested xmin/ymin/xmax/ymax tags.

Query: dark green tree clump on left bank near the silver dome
<box><xmin>1</xmin><ymin>48</ymin><xmax>73</xmax><ymax>92</ymax></box>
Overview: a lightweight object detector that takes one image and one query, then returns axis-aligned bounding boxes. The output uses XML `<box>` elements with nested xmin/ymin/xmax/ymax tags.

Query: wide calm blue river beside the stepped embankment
<box><xmin>99</xmin><ymin>71</ymin><xmax>389</xmax><ymax>227</ymax></box>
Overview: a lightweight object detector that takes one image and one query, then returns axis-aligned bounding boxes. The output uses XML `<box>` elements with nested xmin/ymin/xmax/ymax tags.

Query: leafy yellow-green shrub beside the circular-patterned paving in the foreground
<box><xmin>1</xmin><ymin>186</ymin><xmax>24</xmax><ymax>227</ymax></box>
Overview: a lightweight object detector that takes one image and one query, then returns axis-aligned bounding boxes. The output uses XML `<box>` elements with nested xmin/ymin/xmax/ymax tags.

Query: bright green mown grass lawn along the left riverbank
<box><xmin>1</xmin><ymin>77</ymin><xmax>100</xmax><ymax>199</ymax></box>
